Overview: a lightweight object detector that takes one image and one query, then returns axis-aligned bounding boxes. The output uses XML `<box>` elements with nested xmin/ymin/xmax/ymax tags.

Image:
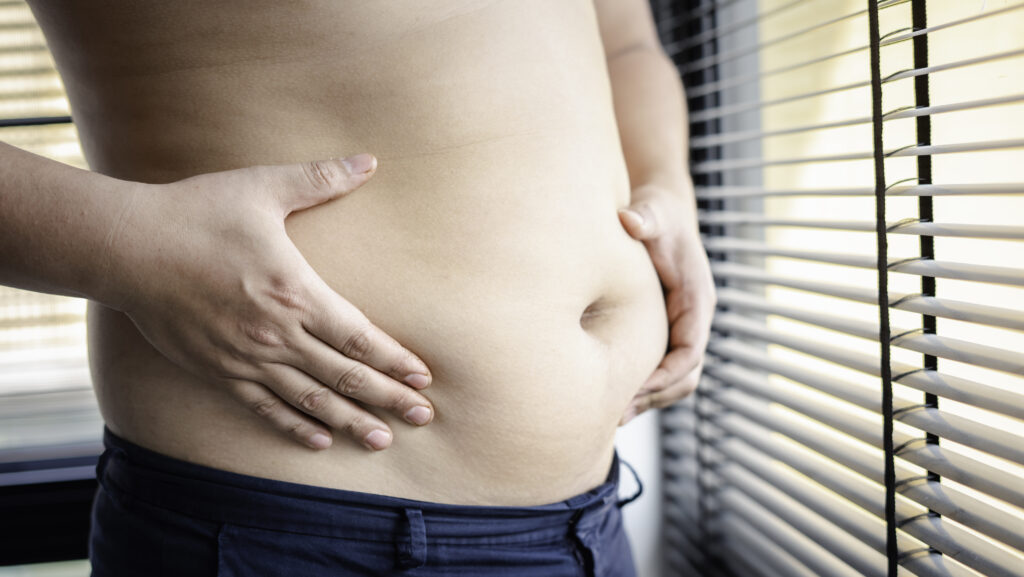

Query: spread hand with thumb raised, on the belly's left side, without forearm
<box><xmin>106</xmin><ymin>155</ymin><xmax>433</xmax><ymax>450</ymax></box>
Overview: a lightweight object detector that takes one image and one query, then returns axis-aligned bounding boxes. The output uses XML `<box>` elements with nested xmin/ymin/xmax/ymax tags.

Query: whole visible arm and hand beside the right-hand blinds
<box><xmin>595</xmin><ymin>0</ymin><xmax>715</xmax><ymax>424</ymax></box>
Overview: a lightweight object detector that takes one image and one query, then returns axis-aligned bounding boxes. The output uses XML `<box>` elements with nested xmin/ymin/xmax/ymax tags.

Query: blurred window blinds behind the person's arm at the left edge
<box><xmin>0</xmin><ymin>0</ymin><xmax>102</xmax><ymax>486</ymax></box>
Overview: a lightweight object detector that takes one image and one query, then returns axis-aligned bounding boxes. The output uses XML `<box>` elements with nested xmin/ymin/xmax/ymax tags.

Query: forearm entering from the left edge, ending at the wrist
<box><xmin>0</xmin><ymin>142</ymin><xmax>137</xmax><ymax>304</ymax></box>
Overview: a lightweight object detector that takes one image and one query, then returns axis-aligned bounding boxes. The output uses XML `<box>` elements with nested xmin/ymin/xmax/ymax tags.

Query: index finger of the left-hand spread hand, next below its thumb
<box><xmin>302</xmin><ymin>284</ymin><xmax>430</xmax><ymax>388</ymax></box>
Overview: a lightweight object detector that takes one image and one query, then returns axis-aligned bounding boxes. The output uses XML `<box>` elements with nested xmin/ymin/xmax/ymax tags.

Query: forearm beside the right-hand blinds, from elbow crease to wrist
<box><xmin>608</xmin><ymin>44</ymin><xmax>696</xmax><ymax>222</ymax></box>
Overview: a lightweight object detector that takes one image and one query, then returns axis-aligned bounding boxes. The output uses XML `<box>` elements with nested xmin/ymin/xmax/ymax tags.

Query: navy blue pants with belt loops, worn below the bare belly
<box><xmin>89</xmin><ymin>430</ymin><xmax>639</xmax><ymax>577</ymax></box>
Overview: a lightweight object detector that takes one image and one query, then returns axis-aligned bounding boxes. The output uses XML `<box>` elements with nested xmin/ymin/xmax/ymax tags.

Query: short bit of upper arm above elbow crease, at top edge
<box><xmin>594</xmin><ymin>0</ymin><xmax>662</xmax><ymax>60</ymax></box>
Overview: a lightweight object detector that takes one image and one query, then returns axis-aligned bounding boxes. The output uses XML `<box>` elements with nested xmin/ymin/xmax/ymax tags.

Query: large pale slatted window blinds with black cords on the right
<box><xmin>651</xmin><ymin>0</ymin><xmax>1024</xmax><ymax>577</ymax></box>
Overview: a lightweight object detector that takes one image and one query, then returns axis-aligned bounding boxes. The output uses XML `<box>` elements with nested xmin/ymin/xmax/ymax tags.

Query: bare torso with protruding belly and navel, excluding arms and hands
<box><xmin>28</xmin><ymin>0</ymin><xmax>668</xmax><ymax>504</ymax></box>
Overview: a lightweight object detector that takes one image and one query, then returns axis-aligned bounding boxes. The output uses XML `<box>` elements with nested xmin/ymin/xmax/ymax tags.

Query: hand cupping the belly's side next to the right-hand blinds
<box><xmin>618</xmin><ymin>186</ymin><xmax>716</xmax><ymax>425</ymax></box>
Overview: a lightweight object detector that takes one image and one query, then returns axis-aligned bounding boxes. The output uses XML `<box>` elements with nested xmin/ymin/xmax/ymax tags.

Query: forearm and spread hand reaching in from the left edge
<box><xmin>0</xmin><ymin>145</ymin><xmax>432</xmax><ymax>450</ymax></box>
